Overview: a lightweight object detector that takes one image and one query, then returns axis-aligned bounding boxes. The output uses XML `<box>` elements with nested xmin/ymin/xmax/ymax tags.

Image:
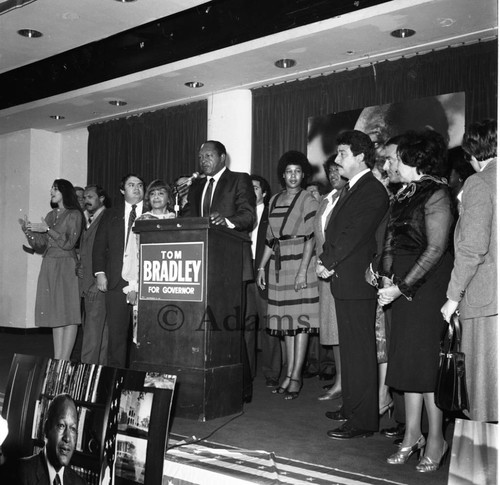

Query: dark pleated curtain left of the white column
<box><xmin>87</xmin><ymin>101</ymin><xmax>207</xmax><ymax>203</ymax></box>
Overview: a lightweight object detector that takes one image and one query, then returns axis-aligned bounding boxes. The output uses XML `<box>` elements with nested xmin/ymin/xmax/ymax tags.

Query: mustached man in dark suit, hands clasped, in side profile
<box><xmin>317</xmin><ymin>130</ymin><xmax>389</xmax><ymax>439</ymax></box>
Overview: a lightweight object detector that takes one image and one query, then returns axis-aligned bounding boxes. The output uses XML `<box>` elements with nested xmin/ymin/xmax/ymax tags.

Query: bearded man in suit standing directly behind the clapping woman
<box><xmin>76</xmin><ymin>185</ymin><xmax>108</xmax><ymax>365</ymax></box>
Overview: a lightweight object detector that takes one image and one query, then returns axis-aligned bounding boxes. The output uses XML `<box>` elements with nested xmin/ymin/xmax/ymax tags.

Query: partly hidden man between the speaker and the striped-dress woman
<box><xmin>245</xmin><ymin>175</ymin><xmax>281</xmax><ymax>387</ymax></box>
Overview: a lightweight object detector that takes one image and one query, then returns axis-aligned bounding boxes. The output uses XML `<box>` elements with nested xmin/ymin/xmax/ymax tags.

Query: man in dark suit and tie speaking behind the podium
<box><xmin>182</xmin><ymin>140</ymin><xmax>256</xmax><ymax>402</ymax></box>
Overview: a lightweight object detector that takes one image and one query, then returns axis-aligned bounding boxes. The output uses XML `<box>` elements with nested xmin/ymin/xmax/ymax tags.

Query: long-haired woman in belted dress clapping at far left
<box><xmin>22</xmin><ymin>179</ymin><xmax>84</xmax><ymax>359</ymax></box>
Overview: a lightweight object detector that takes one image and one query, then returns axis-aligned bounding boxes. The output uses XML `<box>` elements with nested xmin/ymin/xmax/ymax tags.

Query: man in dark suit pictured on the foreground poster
<box><xmin>17</xmin><ymin>394</ymin><xmax>86</xmax><ymax>485</ymax></box>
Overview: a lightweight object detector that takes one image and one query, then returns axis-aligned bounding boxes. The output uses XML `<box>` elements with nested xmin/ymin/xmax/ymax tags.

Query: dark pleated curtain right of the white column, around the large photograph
<box><xmin>252</xmin><ymin>41</ymin><xmax>498</xmax><ymax>192</ymax></box>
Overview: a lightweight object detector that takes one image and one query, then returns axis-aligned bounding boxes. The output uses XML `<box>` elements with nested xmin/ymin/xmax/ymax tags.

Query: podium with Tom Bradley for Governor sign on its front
<box><xmin>130</xmin><ymin>217</ymin><xmax>250</xmax><ymax>421</ymax></box>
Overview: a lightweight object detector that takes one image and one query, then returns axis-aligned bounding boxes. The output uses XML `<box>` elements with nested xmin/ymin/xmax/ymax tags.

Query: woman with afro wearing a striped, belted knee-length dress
<box><xmin>257</xmin><ymin>151</ymin><xmax>319</xmax><ymax>400</ymax></box>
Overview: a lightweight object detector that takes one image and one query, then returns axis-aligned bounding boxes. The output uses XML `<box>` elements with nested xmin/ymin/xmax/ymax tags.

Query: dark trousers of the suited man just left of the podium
<box><xmin>106</xmin><ymin>286</ymin><xmax>132</xmax><ymax>367</ymax></box>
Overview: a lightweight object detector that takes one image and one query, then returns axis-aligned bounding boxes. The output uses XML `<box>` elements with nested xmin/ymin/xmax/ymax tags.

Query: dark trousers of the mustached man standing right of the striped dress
<box><xmin>335</xmin><ymin>299</ymin><xmax>379</xmax><ymax>431</ymax></box>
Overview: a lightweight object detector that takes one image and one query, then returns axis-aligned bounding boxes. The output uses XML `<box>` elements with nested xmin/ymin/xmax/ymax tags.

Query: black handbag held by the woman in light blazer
<box><xmin>434</xmin><ymin>313</ymin><xmax>469</xmax><ymax>411</ymax></box>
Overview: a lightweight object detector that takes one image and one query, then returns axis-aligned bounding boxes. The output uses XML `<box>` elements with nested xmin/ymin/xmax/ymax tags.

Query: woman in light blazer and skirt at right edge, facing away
<box><xmin>441</xmin><ymin>120</ymin><xmax>498</xmax><ymax>421</ymax></box>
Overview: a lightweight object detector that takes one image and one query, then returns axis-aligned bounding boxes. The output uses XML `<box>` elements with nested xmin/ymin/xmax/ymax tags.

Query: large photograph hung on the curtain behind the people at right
<box><xmin>307</xmin><ymin>93</ymin><xmax>465</xmax><ymax>185</ymax></box>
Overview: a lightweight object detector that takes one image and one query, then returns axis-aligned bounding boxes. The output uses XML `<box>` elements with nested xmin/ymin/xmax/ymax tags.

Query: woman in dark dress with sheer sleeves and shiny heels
<box><xmin>379</xmin><ymin>131</ymin><xmax>453</xmax><ymax>472</ymax></box>
